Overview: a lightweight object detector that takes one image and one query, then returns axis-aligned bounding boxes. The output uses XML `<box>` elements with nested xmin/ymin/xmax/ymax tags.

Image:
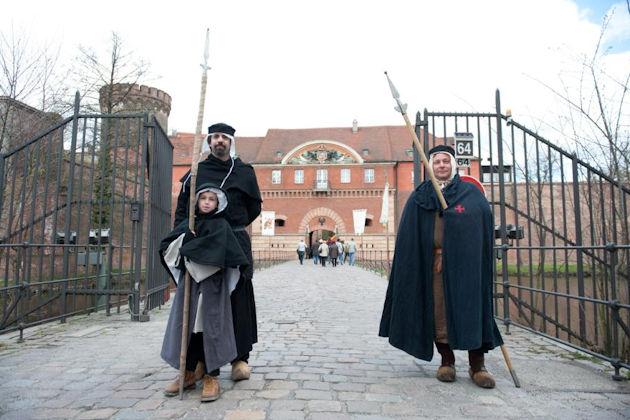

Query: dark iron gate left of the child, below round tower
<box><xmin>0</xmin><ymin>94</ymin><xmax>172</xmax><ymax>333</ymax></box>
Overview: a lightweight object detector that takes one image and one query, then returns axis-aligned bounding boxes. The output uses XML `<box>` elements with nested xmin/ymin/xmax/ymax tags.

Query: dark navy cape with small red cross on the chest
<box><xmin>379</xmin><ymin>175</ymin><xmax>503</xmax><ymax>360</ymax></box>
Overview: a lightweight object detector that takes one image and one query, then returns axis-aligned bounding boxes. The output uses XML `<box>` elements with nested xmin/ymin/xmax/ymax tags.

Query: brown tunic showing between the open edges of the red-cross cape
<box><xmin>433</xmin><ymin>213</ymin><xmax>448</xmax><ymax>344</ymax></box>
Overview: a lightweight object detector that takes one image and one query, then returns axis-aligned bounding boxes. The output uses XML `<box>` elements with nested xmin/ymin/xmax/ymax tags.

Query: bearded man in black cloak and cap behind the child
<box><xmin>175</xmin><ymin>123</ymin><xmax>262</xmax><ymax>390</ymax></box>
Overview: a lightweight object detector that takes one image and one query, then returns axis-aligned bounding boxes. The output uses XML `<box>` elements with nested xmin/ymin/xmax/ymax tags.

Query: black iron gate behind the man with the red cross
<box><xmin>415</xmin><ymin>91</ymin><xmax>630</xmax><ymax>377</ymax></box>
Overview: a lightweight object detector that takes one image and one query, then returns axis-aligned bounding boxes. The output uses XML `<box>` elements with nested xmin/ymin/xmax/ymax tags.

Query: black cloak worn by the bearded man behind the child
<box><xmin>175</xmin><ymin>154</ymin><xmax>262</xmax><ymax>357</ymax></box>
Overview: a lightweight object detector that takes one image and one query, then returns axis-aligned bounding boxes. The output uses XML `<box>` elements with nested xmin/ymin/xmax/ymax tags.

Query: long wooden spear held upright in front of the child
<box><xmin>179</xmin><ymin>29</ymin><xmax>210</xmax><ymax>400</ymax></box>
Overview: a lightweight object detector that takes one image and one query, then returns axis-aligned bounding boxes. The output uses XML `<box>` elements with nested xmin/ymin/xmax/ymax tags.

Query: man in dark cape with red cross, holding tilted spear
<box><xmin>379</xmin><ymin>145</ymin><xmax>503</xmax><ymax>388</ymax></box>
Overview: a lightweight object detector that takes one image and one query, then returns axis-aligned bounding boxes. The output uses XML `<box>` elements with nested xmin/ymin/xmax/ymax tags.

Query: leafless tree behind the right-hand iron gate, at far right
<box><xmin>543</xmin><ymin>7</ymin><xmax>630</xmax><ymax>360</ymax></box>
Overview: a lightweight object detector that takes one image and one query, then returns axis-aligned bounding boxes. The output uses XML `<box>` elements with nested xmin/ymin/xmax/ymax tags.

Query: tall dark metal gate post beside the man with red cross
<box><xmin>496</xmin><ymin>89</ymin><xmax>510</xmax><ymax>334</ymax></box>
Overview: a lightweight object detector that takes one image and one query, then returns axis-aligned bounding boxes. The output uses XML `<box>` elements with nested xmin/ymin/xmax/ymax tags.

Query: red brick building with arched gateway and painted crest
<box><xmin>170</xmin><ymin>123</ymin><xmax>478</xmax><ymax>253</ymax></box>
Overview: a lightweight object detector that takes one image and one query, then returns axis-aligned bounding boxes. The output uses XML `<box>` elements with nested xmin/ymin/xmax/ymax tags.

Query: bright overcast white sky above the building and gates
<box><xmin>0</xmin><ymin>0</ymin><xmax>630</xmax><ymax>136</ymax></box>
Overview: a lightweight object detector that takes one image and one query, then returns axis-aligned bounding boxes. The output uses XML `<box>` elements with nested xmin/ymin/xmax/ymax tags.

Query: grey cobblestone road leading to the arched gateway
<box><xmin>0</xmin><ymin>260</ymin><xmax>630</xmax><ymax>420</ymax></box>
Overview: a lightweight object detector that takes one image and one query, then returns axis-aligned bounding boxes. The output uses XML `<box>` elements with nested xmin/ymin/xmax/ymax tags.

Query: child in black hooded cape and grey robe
<box><xmin>160</xmin><ymin>184</ymin><xmax>248</xmax><ymax>401</ymax></box>
